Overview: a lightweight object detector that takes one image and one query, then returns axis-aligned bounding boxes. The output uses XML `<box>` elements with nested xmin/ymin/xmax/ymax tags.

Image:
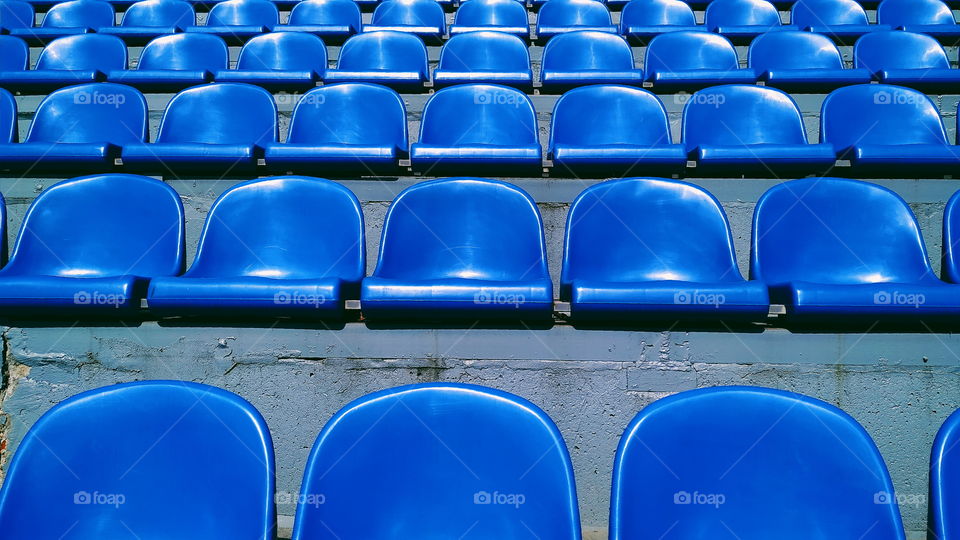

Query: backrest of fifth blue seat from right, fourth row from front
<box><xmin>437</xmin><ymin>31</ymin><xmax>530</xmax><ymax>72</ymax></box>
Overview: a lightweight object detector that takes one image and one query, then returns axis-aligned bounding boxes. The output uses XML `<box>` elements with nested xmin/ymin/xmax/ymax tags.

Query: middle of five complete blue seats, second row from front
<box><xmin>360</xmin><ymin>178</ymin><xmax>553</xmax><ymax>322</ymax></box>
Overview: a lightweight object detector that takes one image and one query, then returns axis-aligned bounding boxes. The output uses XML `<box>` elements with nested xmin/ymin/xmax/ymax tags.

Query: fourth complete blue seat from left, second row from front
<box><xmin>560</xmin><ymin>178</ymin><xmax>770</xmax><ymax>324</ymax></box>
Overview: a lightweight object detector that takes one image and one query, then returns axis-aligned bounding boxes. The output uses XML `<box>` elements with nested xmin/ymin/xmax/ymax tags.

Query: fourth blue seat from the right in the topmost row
<box><xmin>620</xmin><ymin>0</ymin><xmax>704</xmax><ymax>44</ymax></box>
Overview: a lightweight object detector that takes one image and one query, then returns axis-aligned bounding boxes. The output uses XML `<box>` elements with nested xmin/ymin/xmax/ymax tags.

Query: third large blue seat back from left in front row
<box><xmin>610</xmin><ymin>386</ymin><xmax>904</xmax><ymax>540</ymax></box>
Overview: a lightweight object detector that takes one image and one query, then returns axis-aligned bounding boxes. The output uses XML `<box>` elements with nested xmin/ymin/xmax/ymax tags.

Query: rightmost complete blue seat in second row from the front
<box><xmin>750</xmin><ymin>178</ymin><xmax>960</xmax><ymax>322</ymax></box>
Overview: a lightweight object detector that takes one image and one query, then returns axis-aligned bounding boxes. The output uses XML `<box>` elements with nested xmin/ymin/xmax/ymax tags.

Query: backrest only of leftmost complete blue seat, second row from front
<box><xmin>3</xmin><ymin>174</ymin><xmax>184</xmax><ymax>278</ymax></box>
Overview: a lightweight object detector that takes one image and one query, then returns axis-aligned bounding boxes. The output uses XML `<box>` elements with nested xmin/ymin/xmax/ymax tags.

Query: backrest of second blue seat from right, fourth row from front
<box><xmin>747</xmin><ymin>30</ymin><xmax>843</xmax><ymax>73</ymax></box>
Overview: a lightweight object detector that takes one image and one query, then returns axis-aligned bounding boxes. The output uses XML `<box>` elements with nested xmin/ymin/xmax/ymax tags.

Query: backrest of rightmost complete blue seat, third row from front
<box><xmin>820</xmin><ymin>84</ymin><xmax>948</xmax><ymax>150</ymax></box>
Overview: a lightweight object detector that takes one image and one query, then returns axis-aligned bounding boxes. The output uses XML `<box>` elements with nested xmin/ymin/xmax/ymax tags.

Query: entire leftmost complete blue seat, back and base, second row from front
<box><xmin>0</xmin><ymin>174</ymin><xmax>184</xmax><ymax>316</ymax></box>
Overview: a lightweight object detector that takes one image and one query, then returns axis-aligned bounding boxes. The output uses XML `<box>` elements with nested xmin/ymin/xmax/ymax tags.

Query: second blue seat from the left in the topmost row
<box><xmin>8</xmin><ymin>0</ymin><xmax>116</xmax><ymax>46</ymax></box>
